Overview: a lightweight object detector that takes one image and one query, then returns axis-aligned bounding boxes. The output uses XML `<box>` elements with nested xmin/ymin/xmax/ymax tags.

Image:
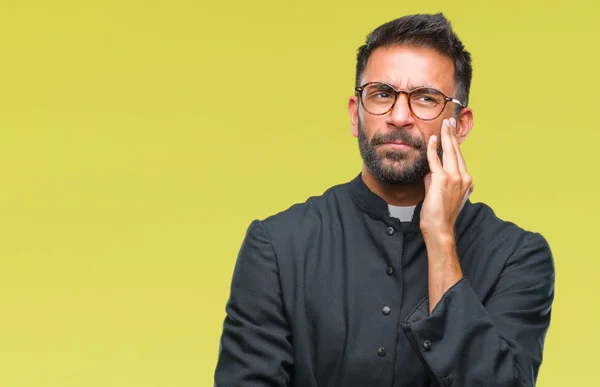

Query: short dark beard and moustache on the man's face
<box><xmin>358</xmin><ymin>118</ymin><xmax>442</xmax><ymax>185</ymax></box>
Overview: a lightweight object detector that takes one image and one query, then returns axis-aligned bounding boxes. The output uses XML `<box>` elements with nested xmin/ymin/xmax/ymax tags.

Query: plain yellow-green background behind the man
<box><xmin>0</xmin><ymin>0</ymin><xmax>600</xmax><ymax>387</ymax></box>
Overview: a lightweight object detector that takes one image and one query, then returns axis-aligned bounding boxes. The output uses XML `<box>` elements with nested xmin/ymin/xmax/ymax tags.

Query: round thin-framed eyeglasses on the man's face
<box><xmin>355</xmin><ymin>82</ymin><xmax>466</xmax><ymax>121</ymax></box>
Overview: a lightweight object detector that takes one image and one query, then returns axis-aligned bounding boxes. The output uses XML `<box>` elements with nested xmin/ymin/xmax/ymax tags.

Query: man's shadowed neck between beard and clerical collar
<box><xmin>362</xmin><ymin>166</ymin><xmax>425</xmax><ymax>207</ymax></box>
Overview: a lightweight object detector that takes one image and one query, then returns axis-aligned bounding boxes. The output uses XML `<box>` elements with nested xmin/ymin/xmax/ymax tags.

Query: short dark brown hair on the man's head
<box><xmin>355</xmin><ymin>13</ymin><xmax>473</xmax><ymax>105</ymax></box>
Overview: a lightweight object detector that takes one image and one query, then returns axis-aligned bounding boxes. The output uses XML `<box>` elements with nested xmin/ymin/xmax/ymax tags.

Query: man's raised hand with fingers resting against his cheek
<box><xmin>420</xmin><ymin>118</ymin><xmax>473</xmax><ymax>239</ymax></box>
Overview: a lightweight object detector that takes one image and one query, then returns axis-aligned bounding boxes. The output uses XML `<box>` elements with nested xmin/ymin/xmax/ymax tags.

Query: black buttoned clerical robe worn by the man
<box><xmin>215</xmin><ymin>175</ymin><xmax>554</xmax><ymax>387</ymax></box>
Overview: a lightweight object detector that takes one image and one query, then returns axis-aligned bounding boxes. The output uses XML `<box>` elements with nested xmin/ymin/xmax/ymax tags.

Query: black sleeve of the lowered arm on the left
<box><xmin>215</xmin><ymin>220</ymin><xmax>293</xmax><ymax>387</ymax></box>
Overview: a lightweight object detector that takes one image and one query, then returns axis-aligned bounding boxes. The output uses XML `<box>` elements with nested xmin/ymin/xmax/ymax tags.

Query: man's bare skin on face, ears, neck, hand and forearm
<box><xmin>348</xmin><ymin>45</ymin><xmax>473</xmax><ymax>313</ymax></box>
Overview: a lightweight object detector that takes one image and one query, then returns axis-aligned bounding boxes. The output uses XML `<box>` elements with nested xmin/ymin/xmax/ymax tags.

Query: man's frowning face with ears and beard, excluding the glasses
<box><xmin>349</xmin><ymin>46</ymin><xmax>470</xmax><ymax>184</ymax></box>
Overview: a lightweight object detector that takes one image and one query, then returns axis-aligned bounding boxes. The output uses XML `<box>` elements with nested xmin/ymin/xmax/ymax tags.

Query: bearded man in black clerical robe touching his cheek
<box><xmin>215</xmin><ymin>14</ymin><xmax>554</xmax><ymax>387</ymax></box>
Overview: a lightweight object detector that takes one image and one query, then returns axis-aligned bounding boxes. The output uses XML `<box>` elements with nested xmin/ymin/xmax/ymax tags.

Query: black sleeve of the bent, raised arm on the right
<box><xmin>402</xmin><ymin>234</ymin><xmax>555</xmax><ymax>387</ymax></box>
